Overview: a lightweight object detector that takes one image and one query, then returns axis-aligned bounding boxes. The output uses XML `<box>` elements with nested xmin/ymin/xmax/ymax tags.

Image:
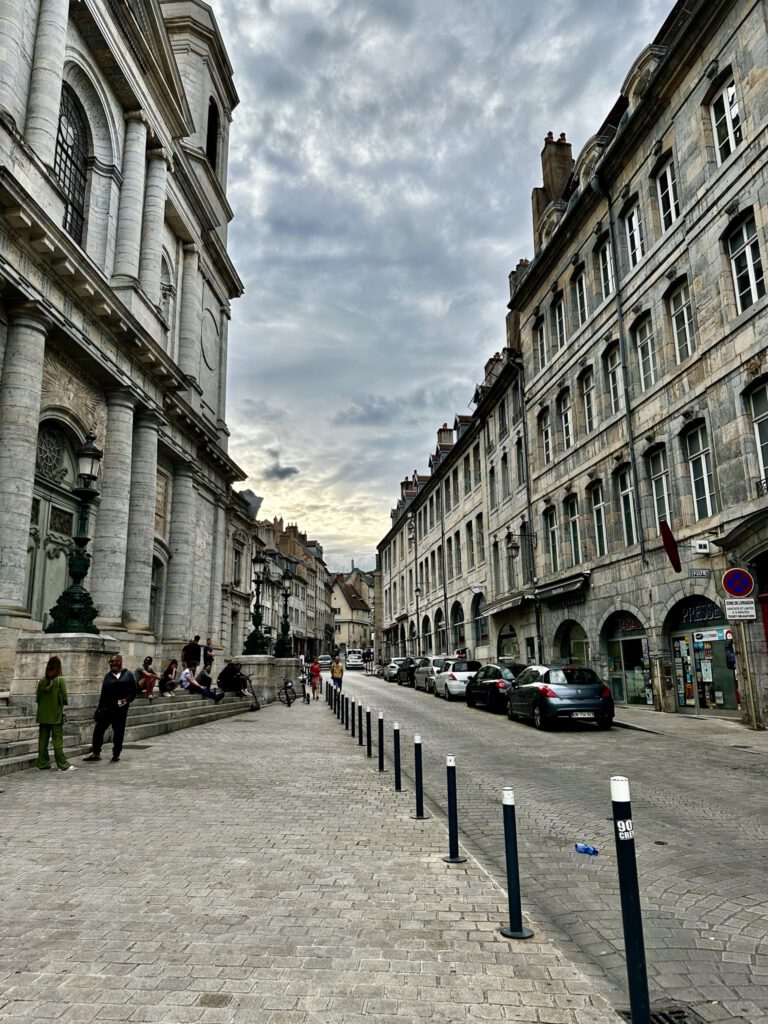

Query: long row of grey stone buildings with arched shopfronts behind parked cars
<box><xmin>379</xmin><ymin>0</ymin><xmax>768</xmax><ymax>726</ymax></box>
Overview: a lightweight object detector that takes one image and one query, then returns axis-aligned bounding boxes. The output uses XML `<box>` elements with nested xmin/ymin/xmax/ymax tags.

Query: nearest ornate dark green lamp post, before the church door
<box><xmin>45</xmin><ymin>434</ymin><xmax>103</xmax><ymax>633</ymax></box>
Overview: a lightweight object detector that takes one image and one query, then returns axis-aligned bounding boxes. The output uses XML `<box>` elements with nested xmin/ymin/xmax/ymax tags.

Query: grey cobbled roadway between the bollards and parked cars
<box><xmin>337</xmin><ymin>674</ymin><xmax>768</xmax><ymax>1024</ymax></box>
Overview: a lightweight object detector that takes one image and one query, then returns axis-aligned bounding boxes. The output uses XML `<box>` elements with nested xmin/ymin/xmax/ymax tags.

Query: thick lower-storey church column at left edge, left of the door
<box><xmin>0</xmin><ymin>303</ymin><xmax>50</xmax><ymax>612</ymax></box>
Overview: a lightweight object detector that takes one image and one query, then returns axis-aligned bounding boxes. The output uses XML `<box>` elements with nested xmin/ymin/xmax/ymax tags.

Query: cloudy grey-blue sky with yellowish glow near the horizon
<box><xmin>212</xmin><ymin>0</ymin><xmax>673</xmax><ymax>568</ymax></box>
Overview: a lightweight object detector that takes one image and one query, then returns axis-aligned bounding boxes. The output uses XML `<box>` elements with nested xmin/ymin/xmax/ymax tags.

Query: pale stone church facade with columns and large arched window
<box><xmin>0</xmin><ymin>0</ymin><xmax>253</xmax><ymax>689</ymax></box>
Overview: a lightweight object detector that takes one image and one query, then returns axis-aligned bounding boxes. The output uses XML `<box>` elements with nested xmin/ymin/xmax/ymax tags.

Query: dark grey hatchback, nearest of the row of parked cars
<box><xmin>507</xmin><ymin>665</ymin><xmax>613</xmax><ymax>729</ymax></box>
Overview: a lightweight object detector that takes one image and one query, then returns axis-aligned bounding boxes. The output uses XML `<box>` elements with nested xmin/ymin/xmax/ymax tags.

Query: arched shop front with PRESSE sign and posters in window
<box><xmin>667</xmin><ymin>597</ymin><xmax>740</xmax><ymax>718</ymax></box>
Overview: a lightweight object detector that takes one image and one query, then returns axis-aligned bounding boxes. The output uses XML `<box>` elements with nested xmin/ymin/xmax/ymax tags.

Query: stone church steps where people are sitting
<box><xmin>0</xmin><ymin>690</ymin><xmax>252</xmax><ymax>775</ymax></box>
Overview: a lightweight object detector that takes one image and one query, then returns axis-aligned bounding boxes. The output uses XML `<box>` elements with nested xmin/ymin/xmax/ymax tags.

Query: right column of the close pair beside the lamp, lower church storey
<box><xmin>123</xmin><ymin>413</ymin><xmax>161</xmax><ymax>630</ymax></box>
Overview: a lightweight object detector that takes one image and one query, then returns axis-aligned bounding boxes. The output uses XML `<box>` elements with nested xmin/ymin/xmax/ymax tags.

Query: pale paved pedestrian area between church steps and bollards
<box><xmin>0</xmin><ymin>700</ymin><xmax>618</xmax><ymax>1024</ymax></box>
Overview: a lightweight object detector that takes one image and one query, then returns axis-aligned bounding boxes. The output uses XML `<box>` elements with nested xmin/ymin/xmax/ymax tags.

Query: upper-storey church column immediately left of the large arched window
<box><xmin>19</xmin><ymin>0</ymin><xmax>70</xmax><ymax>167</ymax></box>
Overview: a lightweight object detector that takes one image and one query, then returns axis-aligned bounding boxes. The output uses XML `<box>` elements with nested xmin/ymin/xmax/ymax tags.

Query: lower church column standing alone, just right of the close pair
<box><xmin>163</xmin><ymin>463</ymin><xmax>196</xmax><ymax>643</ymax></box>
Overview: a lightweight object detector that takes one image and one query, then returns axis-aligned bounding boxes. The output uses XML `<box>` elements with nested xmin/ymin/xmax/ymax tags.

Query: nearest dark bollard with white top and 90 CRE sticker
<box><xmin>610</xmin><ymin>775</ymin><xmax>650</xmax><ymax>1024</ymax></box>
